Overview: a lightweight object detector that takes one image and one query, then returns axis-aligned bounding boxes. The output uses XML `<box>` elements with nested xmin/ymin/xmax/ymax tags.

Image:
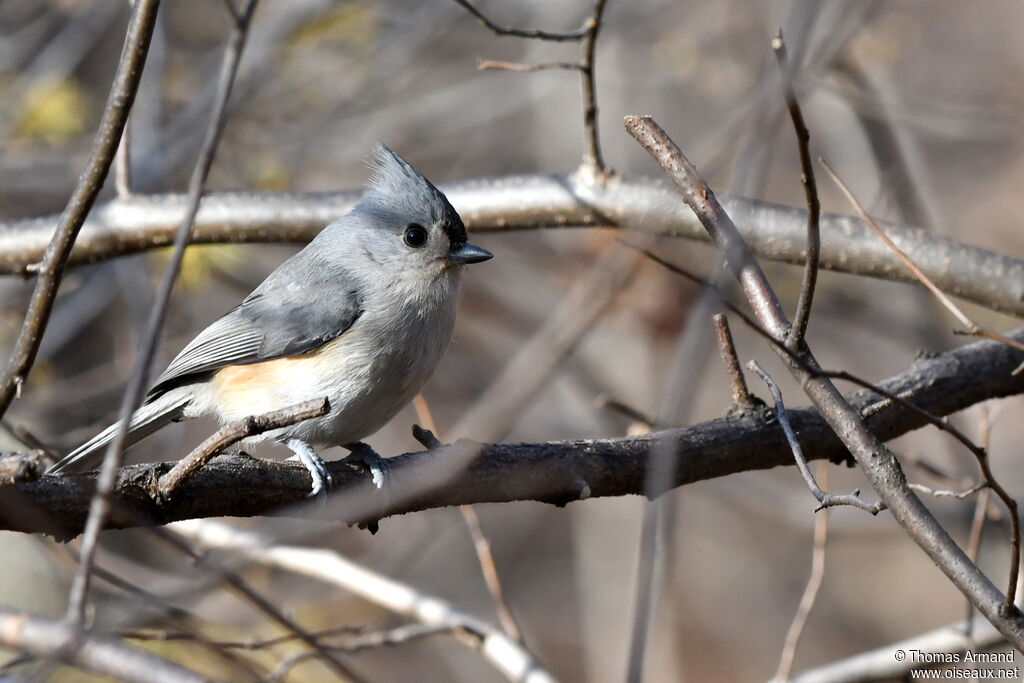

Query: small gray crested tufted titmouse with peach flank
<box><xmin>50</xmin><ymin>143</ymin><xmax>492</xmax><ymax>496</ymax></box>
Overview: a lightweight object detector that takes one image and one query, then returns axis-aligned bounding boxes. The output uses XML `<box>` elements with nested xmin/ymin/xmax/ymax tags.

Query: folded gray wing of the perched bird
<box><xmin>147</xmin><ymin>252</ymin><xmax>362</xmax><ymax>400</ymax></box>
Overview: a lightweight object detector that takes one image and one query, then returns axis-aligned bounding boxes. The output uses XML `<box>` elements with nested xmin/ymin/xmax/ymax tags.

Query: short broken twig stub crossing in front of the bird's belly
<box><xmin>159</xmin><ymin>397</ymin><xmax>331</xmax><ymax>501</ymax></box>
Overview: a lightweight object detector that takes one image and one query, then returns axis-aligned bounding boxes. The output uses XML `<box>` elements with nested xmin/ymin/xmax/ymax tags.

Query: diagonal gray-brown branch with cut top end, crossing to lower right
<box><xmin>626</xmin><ymin>117</ymin><xmax>1024</xmax><ymax>648</ymax></box>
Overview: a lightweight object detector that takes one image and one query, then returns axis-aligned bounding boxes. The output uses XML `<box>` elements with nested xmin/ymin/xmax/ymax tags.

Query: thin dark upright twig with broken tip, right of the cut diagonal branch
<box><xmin>771</xmin><ymin>29</ymin><xmax>821</xmax><ymax>349</ymax></box>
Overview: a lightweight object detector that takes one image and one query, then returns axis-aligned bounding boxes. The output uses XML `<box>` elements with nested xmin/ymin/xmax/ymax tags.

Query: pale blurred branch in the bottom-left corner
<box><xmin>0</xmin><ymin>607</ymin><xmax>207</xmax><ymax>683</ymax></box>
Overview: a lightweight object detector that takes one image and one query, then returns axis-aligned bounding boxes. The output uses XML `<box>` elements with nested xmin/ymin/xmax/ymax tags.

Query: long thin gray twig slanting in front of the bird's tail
<box><xmin>68</xmin><ymin>0</ymin><xmax>257</xmax><ymax>623</ymax></box>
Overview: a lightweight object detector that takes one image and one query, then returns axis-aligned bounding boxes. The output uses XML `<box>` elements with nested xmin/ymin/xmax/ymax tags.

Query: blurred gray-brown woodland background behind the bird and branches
<box><xmin>0</xmin><ymin>0</ymin><xmax>1024</xmax><ymax>681</ymax></box>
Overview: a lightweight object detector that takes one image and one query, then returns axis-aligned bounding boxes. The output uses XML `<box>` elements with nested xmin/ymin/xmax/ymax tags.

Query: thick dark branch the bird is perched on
<box><xmin>0</xmin><ymin>328</ymin><xmax>1024</xmax><ymax>539</ymax></box>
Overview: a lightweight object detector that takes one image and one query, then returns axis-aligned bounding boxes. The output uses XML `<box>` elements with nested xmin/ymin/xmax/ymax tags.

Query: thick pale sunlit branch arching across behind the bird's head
<box><xmin>0</xmin><ymin>174</ymin><xmax>1024</xmax><ymax>316</ymax></box>
